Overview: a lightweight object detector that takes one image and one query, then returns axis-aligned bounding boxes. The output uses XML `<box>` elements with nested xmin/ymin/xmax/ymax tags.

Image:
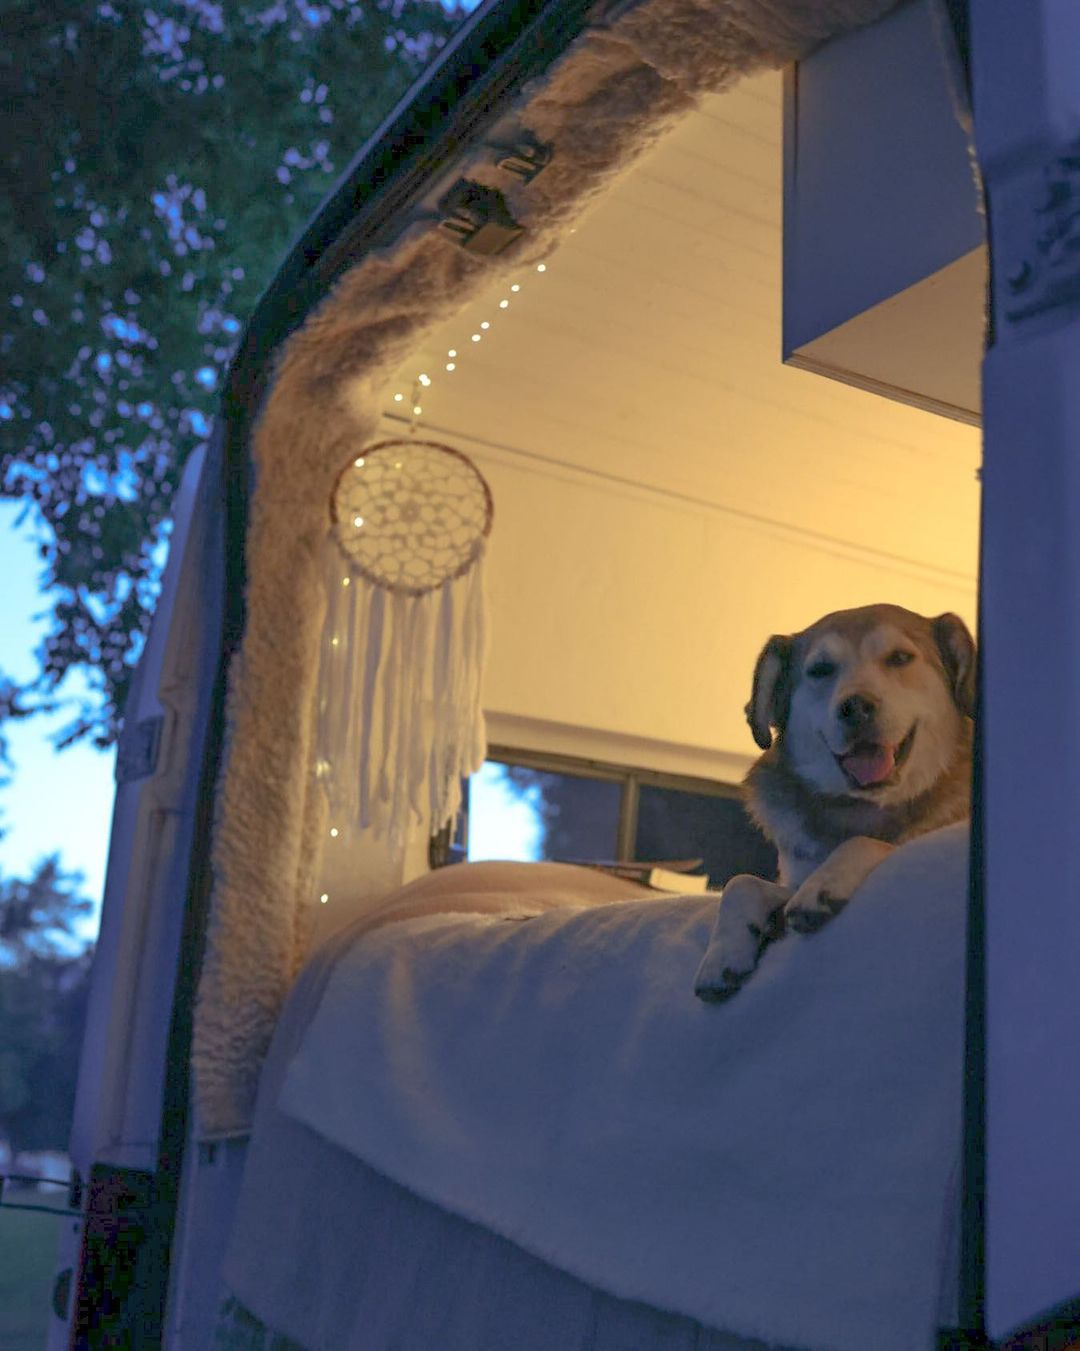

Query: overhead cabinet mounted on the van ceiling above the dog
<box><xmin>784</xmin><ymin>0</ymin><xmax>987</xmax><ymax>423</ymax></box>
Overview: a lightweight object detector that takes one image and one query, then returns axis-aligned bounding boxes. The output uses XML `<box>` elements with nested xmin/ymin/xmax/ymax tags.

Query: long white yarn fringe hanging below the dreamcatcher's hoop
<box><xmin>318</xmin><ymin>536</ymin><xmax>487</xmax><ymax>840</ymax></box>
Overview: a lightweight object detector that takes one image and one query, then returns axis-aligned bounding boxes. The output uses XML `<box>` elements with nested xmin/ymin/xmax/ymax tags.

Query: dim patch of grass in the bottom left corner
<box><xmin>0</xmin><ymin>1188</ymin><xmax>66</xmax><ymax>1351</ymax></box>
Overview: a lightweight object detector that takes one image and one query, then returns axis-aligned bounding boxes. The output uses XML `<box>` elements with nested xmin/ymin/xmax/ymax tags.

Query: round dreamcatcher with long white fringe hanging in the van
<box><xmin>319</xmin><ymin>439</ymin><xmax>493</xmax><ymax>839</ymax></box>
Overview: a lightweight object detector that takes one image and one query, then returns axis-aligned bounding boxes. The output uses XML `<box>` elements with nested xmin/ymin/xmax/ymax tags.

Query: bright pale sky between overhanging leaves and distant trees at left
<box><xmin>0</xmin><ymin>501</ymin><xmax>114</xmax><ymax>929</ymax></box>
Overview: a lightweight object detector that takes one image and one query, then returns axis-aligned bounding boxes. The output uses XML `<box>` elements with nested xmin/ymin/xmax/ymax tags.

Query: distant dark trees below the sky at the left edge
<box><xmin>0</xmin><ymin>858</ymin><xmax>92</xmax><ymax>1154</ymax></box>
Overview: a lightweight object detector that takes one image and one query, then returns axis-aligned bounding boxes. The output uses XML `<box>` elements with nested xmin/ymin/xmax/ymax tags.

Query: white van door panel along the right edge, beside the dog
<box><xmin>964</xmin><ymin>0</ymin><xmax>1080</xmax><ymax>1347</ymax></box>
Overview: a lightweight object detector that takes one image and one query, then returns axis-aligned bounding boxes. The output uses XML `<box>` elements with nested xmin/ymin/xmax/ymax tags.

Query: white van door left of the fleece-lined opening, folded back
<box><xmin>47</xmin><ymin>432</ymin><xmax>224</xmax><ymax>1351</ymax></box>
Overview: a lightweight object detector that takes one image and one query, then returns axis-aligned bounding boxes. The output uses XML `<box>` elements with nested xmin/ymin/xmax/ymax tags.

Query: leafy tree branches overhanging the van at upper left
<box><xmin>0</xmin><ymin>0</ymin><xmax>460</xmax><ymax>744</ymax></box>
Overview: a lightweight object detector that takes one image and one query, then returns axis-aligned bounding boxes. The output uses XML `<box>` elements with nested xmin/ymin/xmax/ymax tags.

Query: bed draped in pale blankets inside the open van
<box><xmin>216</xmin><ymin>827</ymin><xmax>966</xmax><ymax>1351</ymax></box>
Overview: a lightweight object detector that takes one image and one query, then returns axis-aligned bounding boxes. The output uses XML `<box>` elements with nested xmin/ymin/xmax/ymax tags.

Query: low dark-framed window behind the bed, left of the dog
<box><xmin>431</xmin><ymin>747</ymin><xmax>776</xmax><ymax>886</ymax></box>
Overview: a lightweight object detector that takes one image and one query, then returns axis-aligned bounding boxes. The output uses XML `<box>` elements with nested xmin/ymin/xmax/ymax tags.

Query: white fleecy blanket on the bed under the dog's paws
<box><xmin>280</xmin><ymin>828</ymin><xmax>966</xmax><ymax>1351</ymax></box>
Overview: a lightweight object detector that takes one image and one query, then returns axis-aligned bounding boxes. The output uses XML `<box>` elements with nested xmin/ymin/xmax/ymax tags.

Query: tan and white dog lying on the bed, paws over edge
<box><xmin>695</xmin><ymin>605</ymin><xmax>976</xmax><ymax>1000</ymax></box>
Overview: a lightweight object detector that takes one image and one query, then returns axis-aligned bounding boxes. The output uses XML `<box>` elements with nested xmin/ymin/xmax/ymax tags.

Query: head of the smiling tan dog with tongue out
<box><xmin>746</xmin><ymin>605</ymin><xmax>975</xmax><ymax>805</ymax></box>
